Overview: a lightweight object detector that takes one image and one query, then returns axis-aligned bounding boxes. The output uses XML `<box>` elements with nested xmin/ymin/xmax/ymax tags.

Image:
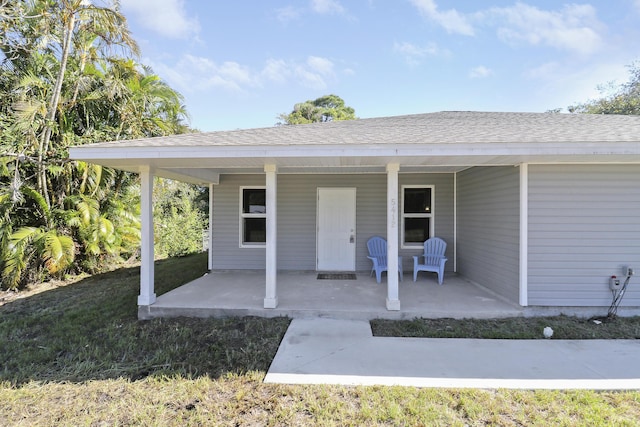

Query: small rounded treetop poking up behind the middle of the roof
<box><xmin>278</xmin><ymin>95</ymin><xmax>357</xmax><ymax>125</ymax></box>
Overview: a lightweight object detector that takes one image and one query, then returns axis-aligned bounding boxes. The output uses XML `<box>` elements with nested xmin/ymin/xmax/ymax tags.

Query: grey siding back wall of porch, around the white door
<box><xmin>213</xmin><ymin>173</ymin><xmax>454</xmax><ymax>277</ymax></box>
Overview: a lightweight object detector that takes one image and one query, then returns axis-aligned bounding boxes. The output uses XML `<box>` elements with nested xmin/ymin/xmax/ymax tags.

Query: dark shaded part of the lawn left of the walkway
<box><xmin>0</xmin><ymin>255</ymin><xmax>289</xmax><ymax>385</ymax></box>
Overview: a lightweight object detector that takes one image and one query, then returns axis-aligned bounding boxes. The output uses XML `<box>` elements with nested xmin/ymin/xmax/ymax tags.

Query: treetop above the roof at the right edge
<box><xmin>568</xmin><ymin>62</ymin><xmax>640</xmax><ymax>115</ymax></box>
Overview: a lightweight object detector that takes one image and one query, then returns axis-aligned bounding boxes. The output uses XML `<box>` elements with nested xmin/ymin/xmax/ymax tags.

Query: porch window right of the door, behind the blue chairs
<box><xmin>402</xmin><ymin>185</ymin><xmax>434</xmax><ymax>248</ymax></box>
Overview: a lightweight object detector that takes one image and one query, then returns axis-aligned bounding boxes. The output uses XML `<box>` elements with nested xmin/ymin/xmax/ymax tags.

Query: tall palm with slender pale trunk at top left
<box><xmin>0</xmin><ymin>0</ymin><xmax>138</xmax><ymax>207</ymax></box>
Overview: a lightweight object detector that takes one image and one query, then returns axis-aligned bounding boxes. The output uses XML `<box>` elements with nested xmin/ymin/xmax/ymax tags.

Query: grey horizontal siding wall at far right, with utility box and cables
<box><xmin>528</xmin><ymin>165</ymin><xmax>640</xmax><ymax>307</ymax></box>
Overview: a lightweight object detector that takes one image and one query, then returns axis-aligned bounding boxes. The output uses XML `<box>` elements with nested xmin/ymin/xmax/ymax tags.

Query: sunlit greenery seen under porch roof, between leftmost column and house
<box><xmin>153</xmin><ymin>178</ymin><xmax>206</xmax><ymax>257</ymax></box>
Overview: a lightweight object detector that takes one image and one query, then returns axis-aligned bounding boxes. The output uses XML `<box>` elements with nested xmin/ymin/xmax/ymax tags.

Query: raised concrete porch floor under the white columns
<box><xmin>139</xmin><ymin>270</ymin><xmax>524</xmax><ymax>320</ymax></box>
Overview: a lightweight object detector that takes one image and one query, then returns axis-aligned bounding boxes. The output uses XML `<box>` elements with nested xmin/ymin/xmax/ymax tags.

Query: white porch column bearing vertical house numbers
<box><xmin>387</xmin><ymin>163</ymin><xmax>400</xmax><ymax>311</ymax></box>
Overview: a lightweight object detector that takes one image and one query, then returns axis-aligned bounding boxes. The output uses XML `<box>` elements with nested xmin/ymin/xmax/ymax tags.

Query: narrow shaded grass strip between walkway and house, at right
<box><xmin>371</xmin><ymin>316</ymin><xmax>640</xmax><ymax>340</ymax></box>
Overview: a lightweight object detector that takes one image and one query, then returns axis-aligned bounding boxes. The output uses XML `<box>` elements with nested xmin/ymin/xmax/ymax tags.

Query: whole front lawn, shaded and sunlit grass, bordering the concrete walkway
<box><xmin>0</xmin><ymin>255</ymin><xmax>640</xmax><ymax>426</ymax></box>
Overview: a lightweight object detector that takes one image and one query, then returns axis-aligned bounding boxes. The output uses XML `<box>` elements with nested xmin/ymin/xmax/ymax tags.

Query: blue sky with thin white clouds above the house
<box><xmin>121</xmin><ymin>0</ymin><xmax>640</xmax><ymax>131</ymax></box>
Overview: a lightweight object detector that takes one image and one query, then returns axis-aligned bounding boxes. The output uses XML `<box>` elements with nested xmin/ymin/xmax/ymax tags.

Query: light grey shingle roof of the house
<box><xmin>85</xmin><ymin>111</ymin><xmax>640</xmax><ymax>148</ymax></box>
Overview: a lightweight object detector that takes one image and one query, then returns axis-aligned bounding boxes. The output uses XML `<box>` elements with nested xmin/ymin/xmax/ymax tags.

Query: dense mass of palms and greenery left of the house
<box><xmin>0</xmin><ymin>0</ymin><xmax>188</xmax><ymax>288</ymax></box>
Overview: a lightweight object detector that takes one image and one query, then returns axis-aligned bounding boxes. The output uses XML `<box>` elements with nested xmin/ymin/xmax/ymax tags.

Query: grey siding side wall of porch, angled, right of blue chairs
<box><xmin>457</xmin><ymin>166</ymin><xmax>520</xmax><ymax>303</ymax></box>
